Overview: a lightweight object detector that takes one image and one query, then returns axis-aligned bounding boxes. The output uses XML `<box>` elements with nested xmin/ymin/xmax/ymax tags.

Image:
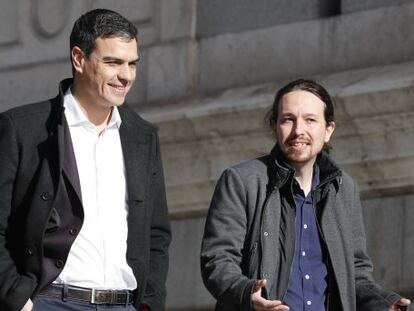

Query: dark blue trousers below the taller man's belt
<box><xmin>32</xmin><ymin>296</ymin><xmax>136</xmax><ymax>311</ymax></box>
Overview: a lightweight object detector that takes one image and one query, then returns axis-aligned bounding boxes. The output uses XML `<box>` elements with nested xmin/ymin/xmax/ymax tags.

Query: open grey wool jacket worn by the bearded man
<box><xmin>201</xmin><ymin>147</ymin><xmax>400</xmax><ymax>311</ymax></box>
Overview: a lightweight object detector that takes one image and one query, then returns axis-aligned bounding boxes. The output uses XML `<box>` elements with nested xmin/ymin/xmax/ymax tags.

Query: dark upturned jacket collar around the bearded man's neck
<box><xmin>269</xmin><ymin>143</ymin><xmax>342</xmax><ymax>190</ymax></box>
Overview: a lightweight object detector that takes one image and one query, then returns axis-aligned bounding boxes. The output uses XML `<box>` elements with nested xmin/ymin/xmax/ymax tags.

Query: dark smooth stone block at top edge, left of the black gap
<box><xmin>196</xmin><ymin>0</ymin><xmax>326</xmax><ymax>38</ymax></box>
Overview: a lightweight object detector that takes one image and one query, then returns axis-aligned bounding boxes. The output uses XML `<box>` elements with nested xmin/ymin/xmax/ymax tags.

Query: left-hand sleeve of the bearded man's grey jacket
<box><xmin>200</xmin><ymin>168</ymin><xmax>256</xmax><ymax>310</ymax></box>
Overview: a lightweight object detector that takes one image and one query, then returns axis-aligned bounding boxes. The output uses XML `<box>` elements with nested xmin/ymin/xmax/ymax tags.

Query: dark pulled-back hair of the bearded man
<box><xmin>266</xmin><ymin>79</ymin><xmax>335</xmax><ymax>151</ymax></box>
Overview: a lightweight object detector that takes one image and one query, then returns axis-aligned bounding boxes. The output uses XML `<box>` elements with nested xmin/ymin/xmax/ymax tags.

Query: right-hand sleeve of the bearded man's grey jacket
<box><xmin>353</xmin><ymin>186</ymin><xmax>401</xmax><ymax>311</ymax></box>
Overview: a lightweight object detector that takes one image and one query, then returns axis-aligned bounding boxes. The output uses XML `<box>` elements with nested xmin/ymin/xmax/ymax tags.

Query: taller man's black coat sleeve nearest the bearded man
<box><xmin>143</xmin><ymin>134</ymin><xmax>171</xmax><ymax>311</ymax></box>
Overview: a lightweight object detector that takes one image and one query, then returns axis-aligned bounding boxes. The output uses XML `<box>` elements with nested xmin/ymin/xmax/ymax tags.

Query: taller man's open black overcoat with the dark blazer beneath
<box><xmin>0</xmin><ymin>79</ymin><xmax>171</xmax><ymax>311</ymax></box>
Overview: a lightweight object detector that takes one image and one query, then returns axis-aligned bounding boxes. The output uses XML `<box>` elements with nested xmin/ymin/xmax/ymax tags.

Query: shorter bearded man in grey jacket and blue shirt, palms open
<box><xmin>201</xmin><ymin>79</ymin><xmax>410</xmax><ymax>311</ymax></box>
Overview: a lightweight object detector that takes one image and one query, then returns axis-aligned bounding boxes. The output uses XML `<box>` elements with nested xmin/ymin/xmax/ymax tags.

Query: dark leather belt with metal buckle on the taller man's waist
<box><xmin>39</xmin><ymin>284</ymin><xmax>134</xmax><ymax>305</ymax></box>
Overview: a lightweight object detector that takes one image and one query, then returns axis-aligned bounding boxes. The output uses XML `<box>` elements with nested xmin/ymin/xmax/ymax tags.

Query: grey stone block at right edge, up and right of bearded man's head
<box><xmin>326</xmin><ymin>3</ymin><xmax>414</xmax><ymax>72</ymax></box>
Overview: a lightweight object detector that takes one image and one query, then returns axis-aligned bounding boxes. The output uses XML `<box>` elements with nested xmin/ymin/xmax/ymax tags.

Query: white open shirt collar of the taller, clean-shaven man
<box><xmin>63</xmin><ymin>87</ymin><xmax>122</xmax><ymax>129</ymax></box>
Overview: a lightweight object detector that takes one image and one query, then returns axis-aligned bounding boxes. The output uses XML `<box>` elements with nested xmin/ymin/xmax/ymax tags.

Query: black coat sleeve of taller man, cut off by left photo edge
<box><xmin>0</xmin><ymin>114</ymin><xmax>36</xmax><ymax>311</ymax></box>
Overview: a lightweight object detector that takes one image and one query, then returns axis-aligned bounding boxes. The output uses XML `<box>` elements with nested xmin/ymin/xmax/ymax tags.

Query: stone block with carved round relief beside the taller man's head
<box><xmin>0</xmin><ymin>0</ymin><xmax>89</xmax><ymax>70</ymax></box>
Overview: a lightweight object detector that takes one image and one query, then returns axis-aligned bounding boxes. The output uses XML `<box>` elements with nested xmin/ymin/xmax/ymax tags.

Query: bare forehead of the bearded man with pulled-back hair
<box><xmin>279</xmin><ymin>90</ymin><xmax>325</xmax><ymax>115</ymax></box>
